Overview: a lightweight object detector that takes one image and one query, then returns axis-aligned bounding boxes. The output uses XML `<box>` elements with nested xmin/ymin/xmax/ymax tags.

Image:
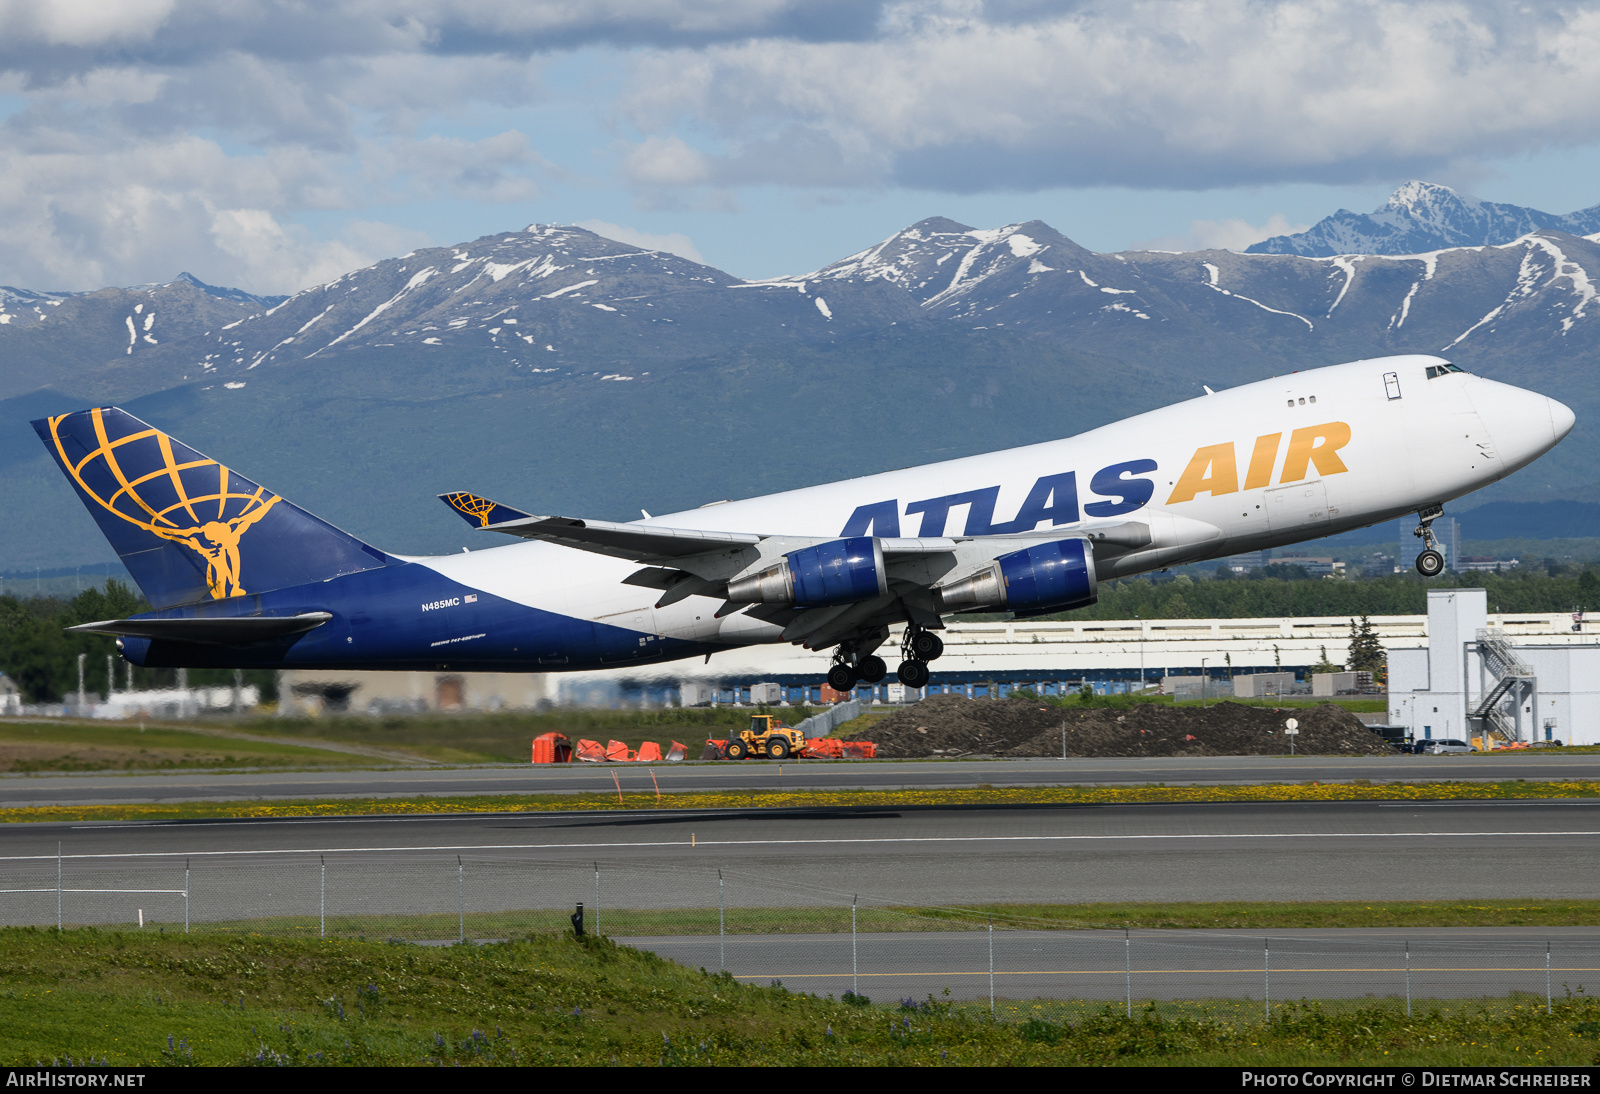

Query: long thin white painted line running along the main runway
<box><xmin>0</xmin><ymin>832</ymin><xmax>1600</xmax><ymax>862</ymax></box>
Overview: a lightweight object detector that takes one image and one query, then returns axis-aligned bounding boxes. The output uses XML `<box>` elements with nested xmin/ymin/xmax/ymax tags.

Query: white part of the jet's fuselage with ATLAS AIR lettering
<box><xmin>416</xmin><ymin>357</ymin><xmax>1573</xmax><ymax>645</ymax></box>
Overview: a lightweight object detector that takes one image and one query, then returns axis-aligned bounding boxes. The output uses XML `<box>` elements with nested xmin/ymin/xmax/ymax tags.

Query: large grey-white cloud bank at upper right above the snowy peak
<box><xmin>629</xmin><ymin>0</ymin><xmax>1600</xmax><ymax>190</ymax></box>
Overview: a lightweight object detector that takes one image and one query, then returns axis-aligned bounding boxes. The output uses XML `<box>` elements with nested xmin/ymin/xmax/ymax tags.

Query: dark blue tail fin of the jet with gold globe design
<box><xmin>34</xmin><ymin>406</ymin><xmax>387</xmax><ymax>608</ymax></box>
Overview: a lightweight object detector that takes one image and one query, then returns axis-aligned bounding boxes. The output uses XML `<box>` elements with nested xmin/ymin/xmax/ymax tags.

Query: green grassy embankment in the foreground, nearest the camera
<box><xmin>0</xmin><ymin>929</ymin><xmax>1600</xmax><ymax>1065</ymax></box>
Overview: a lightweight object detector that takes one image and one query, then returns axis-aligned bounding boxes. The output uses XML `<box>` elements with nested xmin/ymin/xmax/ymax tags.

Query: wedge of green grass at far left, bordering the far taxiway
<box><xmin>0</xmin><ymin>718</ymin><xmax>376</xmax><ymax>773</ymax></box>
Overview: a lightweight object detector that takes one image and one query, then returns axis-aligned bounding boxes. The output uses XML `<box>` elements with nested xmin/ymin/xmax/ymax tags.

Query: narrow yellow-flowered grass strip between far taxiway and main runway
<box><xmin>0</xmin><ymin>765</ymin><xmax>1600</xmax><ymax>824</ymax></box>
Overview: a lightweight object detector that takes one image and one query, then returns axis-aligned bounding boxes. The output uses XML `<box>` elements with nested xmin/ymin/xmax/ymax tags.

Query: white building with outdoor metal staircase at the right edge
<box><xmin>1389</xmin><ymin>589</ymin><xmax>1600</xmax><ymax>744</ymax></box>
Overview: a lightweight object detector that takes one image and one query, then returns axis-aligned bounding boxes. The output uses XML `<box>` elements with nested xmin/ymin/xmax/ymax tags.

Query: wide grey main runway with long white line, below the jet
<box><xmin>0</xmin><ymin>798</ymin><xmax>1600</xmax><ymax>915</ymax></box>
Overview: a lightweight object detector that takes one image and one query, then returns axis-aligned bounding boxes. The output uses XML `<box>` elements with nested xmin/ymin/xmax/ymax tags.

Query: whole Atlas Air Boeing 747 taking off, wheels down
<box><xmin>34</xmin><ymin>357</ymin><xmax>1573</xmax><ymax>691</ymax></box>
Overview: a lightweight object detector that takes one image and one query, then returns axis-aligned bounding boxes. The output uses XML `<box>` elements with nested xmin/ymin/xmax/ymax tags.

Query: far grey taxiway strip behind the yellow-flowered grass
<box><xmin>0</xmin><ymin>749</ymin><xmax>1600</xmax><ymax>808</ymax></box>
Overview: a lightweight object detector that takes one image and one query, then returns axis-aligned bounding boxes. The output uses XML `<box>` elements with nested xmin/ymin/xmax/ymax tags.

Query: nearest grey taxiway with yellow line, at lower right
<box><xmin>619</xmin><ymin>928</ymin><xmax>1600</xmax><ymax>1019</ymax></box>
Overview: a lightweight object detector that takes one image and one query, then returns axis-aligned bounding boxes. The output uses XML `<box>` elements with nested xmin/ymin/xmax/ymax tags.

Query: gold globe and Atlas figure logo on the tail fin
<box><xmin>48</xmin><ymin>409</ymin><xmax>278</xmax><ymax>600</ymax></box>
